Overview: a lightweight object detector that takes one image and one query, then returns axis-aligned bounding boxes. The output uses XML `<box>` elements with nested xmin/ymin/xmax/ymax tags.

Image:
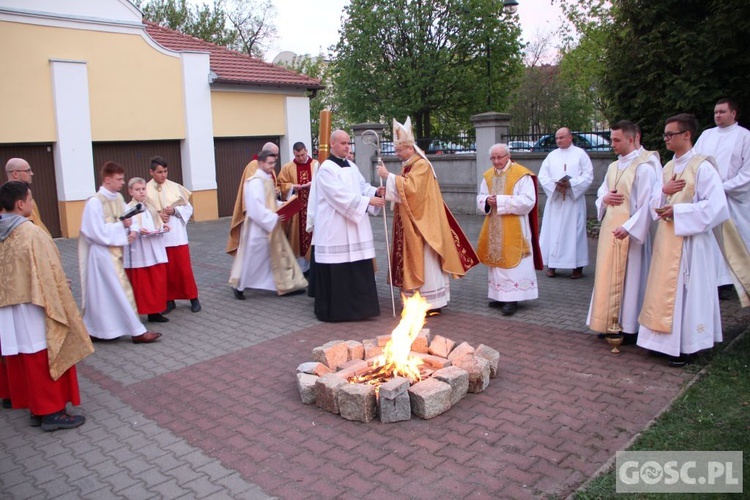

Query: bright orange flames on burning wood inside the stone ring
<box><xmin>351</xmin><ymin>292</ymin><xmax>430</xmax><ymax>386</ymax></box>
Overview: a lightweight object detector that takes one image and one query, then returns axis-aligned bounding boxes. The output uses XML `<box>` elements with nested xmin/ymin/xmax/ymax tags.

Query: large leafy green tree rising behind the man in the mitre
<box><xmin>333</xmin><ymin>0</ymin><xmax>521</xmax><ymax>139</ymax></box>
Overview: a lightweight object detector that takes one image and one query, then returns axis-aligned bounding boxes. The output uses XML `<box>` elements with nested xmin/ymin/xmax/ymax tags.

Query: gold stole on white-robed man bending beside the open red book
<box><xmin>262</xmin><ymin>178</ymin><xmax>307</xmax><ymax>295</ymax></box>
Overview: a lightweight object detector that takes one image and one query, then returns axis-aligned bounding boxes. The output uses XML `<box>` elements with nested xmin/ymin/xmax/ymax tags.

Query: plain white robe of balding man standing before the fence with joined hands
<box><xmin>538</xmin><ymin>146</ymin><xmax>594</xmax><ymax>269</ymax></box>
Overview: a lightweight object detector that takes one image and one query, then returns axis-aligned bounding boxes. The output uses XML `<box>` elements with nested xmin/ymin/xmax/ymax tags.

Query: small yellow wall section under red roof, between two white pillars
<box><xmin>211</xmin><ymin>91</ymin><xmax>286</xmax><ymax>137</ymax></box>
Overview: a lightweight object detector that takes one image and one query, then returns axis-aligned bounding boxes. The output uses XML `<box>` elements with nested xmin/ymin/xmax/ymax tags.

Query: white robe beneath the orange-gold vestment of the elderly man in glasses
<box><xmin>477</xmin><ymin>166</ymin><xmax>539</xmax><ymax>302</ymax></box>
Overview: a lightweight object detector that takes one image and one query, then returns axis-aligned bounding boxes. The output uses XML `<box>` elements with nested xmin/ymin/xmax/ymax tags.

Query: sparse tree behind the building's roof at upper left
<box><xmin>136</xmin><ymin>0</ymin><xmax>237</xmax><ymax>46</ymax></box>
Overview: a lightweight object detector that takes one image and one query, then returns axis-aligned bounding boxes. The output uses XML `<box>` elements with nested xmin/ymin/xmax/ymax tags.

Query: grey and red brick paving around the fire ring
<box><xmin>0</xmin><ymin>216</ymin><xmax>750</xmax><ymax>499</ymax></box>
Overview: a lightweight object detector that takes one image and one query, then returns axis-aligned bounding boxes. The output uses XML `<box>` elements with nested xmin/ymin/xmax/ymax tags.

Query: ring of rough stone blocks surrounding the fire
<box><xmin>297</xmin><ymin>328</ymin><xmax>500</xmax><ymax>423</ymax></box>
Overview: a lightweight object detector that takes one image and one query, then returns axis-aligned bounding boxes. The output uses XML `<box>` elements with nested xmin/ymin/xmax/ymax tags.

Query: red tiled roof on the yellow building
<box><xmin>143</xmin><ymin>19</ymin><xmax>323</xmax><ymax>90</ymax></box>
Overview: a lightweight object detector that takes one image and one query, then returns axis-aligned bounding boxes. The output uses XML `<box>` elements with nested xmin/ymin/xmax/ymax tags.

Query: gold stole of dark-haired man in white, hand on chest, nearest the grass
<box><xmin>638</xmin><ymin>155</ymin><xmax>706</xmax><ymax>333</ymax></box>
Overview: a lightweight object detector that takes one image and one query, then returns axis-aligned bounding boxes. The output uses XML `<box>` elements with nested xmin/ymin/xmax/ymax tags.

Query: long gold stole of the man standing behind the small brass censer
<box><xmin>589</xmin><ymin>156</ymin><xmax>646</xmax><ymax>333</ymax></box>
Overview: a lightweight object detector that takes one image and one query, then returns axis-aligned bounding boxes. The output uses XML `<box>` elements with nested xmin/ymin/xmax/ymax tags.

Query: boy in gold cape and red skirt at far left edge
<box><xmin>0</xmin><ymin>181</ymin><xmax>94</xmax><ymax>431</ymax></box>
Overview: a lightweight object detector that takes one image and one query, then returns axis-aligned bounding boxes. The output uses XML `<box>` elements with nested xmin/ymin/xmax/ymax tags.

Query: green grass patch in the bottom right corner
<box><xmin>573</xmin><ymin>330</ymin><xmax>750</xmax><ymax>500</ymax></box>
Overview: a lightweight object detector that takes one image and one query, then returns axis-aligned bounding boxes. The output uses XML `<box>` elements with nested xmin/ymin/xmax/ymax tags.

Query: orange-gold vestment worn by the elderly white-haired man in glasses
<box><xmin>477</xmin><ymin>163</ymin><xmax>533</xmax><ymax>269</ymax></box>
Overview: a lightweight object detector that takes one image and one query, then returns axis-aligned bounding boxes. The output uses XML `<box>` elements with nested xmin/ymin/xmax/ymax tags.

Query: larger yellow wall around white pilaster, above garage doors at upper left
<box><xmin>0</xmin><ymin>22</ymin><xmax>185</xmax><ymax>143</ymax></box>
